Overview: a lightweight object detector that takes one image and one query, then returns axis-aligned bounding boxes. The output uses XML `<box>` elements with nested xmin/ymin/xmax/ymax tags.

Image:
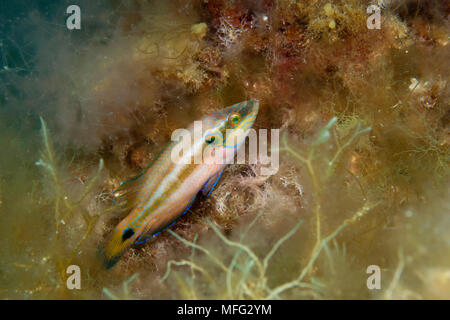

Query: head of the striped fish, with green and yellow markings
<box><xmin>203</xmin><ymin>100</ymin><xmax>259</xmax><ymax>161</ymax></box>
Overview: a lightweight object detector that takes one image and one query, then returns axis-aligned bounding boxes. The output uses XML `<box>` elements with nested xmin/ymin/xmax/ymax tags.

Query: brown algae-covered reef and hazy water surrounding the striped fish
<box><xmin>0</xmin><ymin>0</ymin><xmax>450</xmax><ymax>299</ymax></box>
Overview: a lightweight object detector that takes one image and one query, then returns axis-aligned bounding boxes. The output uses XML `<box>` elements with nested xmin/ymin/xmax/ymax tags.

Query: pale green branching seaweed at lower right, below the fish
<box><xmin>162</xmin><ymin>118</ymin><xmax>380</xmax><ymax>299</ymax></box>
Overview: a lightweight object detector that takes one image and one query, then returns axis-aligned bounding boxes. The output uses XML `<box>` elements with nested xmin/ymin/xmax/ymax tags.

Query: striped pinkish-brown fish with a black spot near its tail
<box><xmin>100</xmin><ymin>100</ymin><xmax>259</xmax><ymax>269</ymax></box>
